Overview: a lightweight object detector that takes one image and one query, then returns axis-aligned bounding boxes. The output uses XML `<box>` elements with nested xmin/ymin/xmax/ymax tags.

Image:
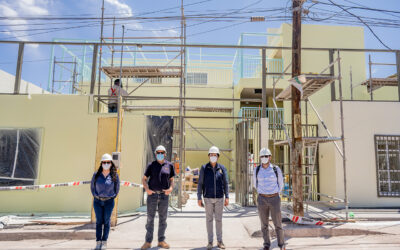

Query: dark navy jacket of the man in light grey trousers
<box><xmin>197</xmin><ymin>163</ymin><xmax>229</xmax><ymax>200</ymax></box>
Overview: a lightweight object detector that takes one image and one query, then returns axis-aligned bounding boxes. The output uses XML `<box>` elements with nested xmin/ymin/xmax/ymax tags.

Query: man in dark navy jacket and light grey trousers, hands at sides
<box><xmin>197</xmin><ymin>146</ymin><xmax>229</xmax><ymax>249</ymax></box>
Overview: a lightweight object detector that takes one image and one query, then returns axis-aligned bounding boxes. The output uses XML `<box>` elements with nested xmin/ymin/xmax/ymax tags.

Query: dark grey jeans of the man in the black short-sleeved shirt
<box><xmin>146</xmin><ymin>194</ymin><xmax>168</xmax><ymax>242</ymax></box>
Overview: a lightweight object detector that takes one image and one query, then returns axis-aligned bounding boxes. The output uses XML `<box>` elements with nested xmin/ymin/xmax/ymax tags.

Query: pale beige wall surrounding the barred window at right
<box><xmin>319</xmin><ymin>102</ymin><xmax>400</xmax><ymax>207</ymax></box>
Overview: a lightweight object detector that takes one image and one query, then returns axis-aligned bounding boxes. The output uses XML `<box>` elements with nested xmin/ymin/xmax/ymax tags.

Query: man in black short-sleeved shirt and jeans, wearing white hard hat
<box><xmin>141</xmin><ymin>145</ymin><xmax>175</xmax><ymax>249</ymax></box>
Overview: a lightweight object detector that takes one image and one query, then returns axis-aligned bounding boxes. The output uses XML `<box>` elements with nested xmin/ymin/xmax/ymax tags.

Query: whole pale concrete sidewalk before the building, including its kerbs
<box><xmin>0</xmin><ymin>195</ymin><xmax>400</xmax><ymax>250</ymax></box>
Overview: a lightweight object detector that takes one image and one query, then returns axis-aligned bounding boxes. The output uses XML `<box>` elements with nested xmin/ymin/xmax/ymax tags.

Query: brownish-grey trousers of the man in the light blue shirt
<box><xmin>257</xmin><ymin>195</ymin><xmax>285</xmax><ymax>248</ymax></box>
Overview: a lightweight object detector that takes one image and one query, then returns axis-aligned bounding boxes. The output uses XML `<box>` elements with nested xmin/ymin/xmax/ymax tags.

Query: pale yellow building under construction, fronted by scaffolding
<box><xmin>0</xmin><ymin>21</ymin><xmax>400</xmax><ymax>217</ymax></box>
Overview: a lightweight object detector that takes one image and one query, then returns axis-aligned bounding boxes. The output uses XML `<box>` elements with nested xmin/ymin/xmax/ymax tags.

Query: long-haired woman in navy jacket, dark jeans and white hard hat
<box><xmin>90</xmin><ymin>154</ymin><xmax>120</xmax><ymax>249</ymax></box>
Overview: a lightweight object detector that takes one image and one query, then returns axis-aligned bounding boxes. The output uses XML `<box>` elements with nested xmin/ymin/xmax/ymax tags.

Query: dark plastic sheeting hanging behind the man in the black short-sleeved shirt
<box><xmin>146</xmin><ymin>116</ymin><xmax>174</xmax><ymax>163</ymax></box>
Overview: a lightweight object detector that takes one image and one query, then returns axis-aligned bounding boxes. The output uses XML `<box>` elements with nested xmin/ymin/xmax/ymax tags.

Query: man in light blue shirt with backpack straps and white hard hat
<box><xmin>253</xmin><ymin>148</ymin><xmax>285</xmax><ymax>250</ymax></box>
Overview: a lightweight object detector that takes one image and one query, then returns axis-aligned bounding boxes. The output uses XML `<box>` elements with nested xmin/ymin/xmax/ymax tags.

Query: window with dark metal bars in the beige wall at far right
<box><xmin>375</xmin><ymin>135</ymin><xmax>400</xmax><ymax>197</ymax></box>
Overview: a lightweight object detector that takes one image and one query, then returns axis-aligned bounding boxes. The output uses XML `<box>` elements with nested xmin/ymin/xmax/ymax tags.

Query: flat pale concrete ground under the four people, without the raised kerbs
<box><xmin>0</xmin><ymin>193</ymin><xmax>400</xmax><ymax>250</ymax></box>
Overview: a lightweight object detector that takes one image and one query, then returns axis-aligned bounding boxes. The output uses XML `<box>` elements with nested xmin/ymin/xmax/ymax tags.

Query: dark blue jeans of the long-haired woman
<box><xmin>93</xmin><ymin>198</ymin><xmax>114</xmax><ymax>241</ymax></box>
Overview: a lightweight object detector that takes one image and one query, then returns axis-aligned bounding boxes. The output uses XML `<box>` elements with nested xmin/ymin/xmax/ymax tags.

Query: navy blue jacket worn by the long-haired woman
<box><xmin>90</xmin><ymin>173</ymin><xmax>119</xmax><ymax>198</ymax></box>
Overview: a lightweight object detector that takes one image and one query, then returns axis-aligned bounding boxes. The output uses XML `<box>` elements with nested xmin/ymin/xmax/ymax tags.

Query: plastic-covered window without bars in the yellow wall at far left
<box><xmin>0</xmin><ymin>129</ymin><xmax>41</xmax><ymax>186</ymax></box>
